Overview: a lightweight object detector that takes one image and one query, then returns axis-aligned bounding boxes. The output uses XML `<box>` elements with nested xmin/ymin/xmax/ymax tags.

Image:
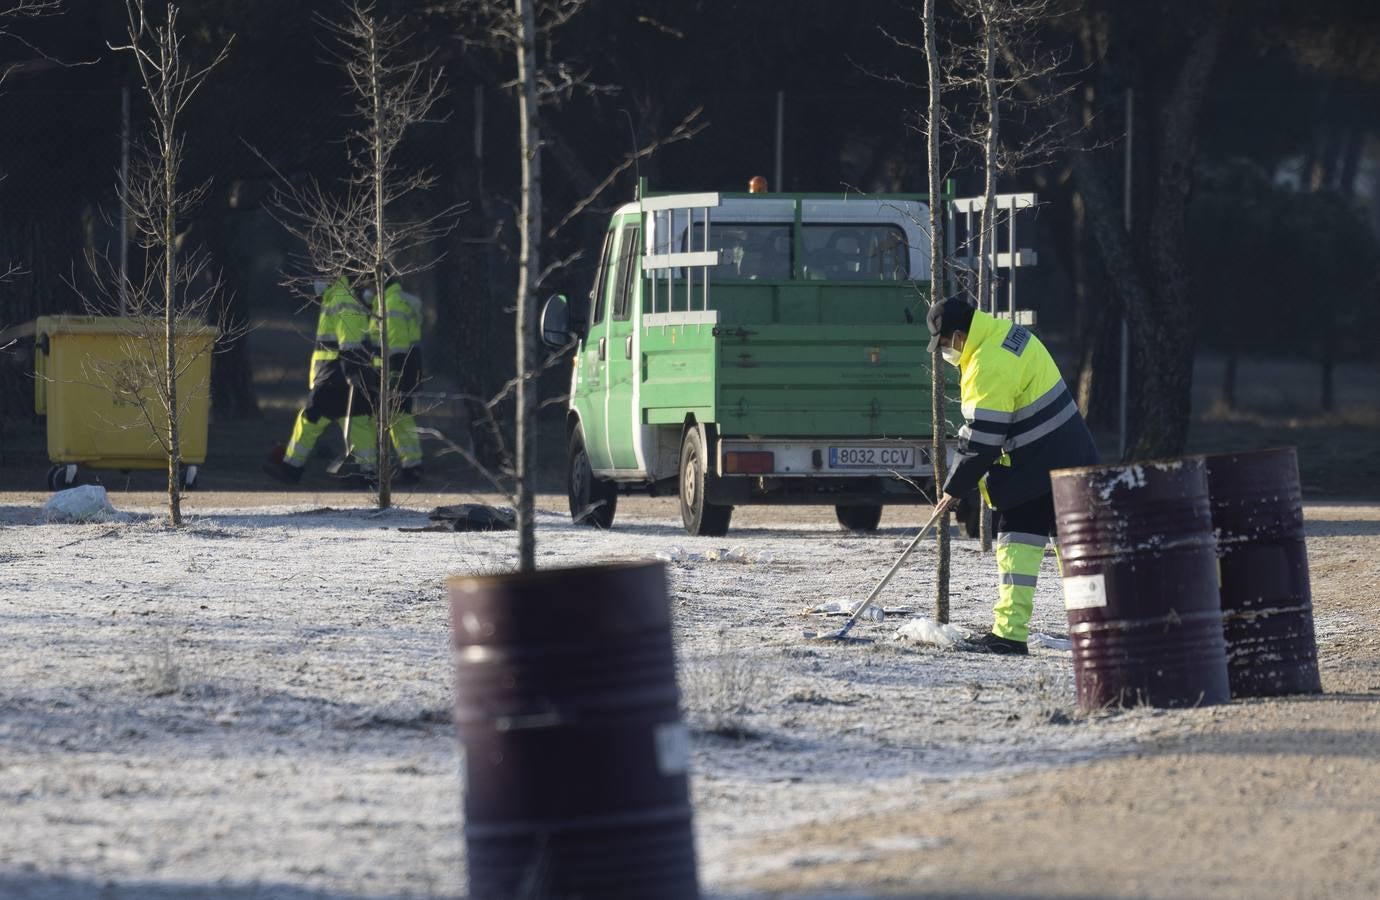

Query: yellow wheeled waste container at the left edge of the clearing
<box><xmin>33</xmin><ymin>316</ymin><xmax>218</xmax><ymax>490</ymax></box>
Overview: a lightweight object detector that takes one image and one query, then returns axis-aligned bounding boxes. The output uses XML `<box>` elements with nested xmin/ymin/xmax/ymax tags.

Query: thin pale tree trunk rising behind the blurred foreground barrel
<box><xmin>513</xmin><ymin>0</ymin><xmax>541</xmax><ymax>571</ymax></box>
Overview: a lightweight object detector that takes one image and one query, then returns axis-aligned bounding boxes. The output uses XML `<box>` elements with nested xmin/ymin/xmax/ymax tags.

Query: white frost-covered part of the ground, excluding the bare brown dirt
<box><xmin>0</xmin><ymin>496</ymin><xmax>1355</xmax><ymax>897</ymax></box>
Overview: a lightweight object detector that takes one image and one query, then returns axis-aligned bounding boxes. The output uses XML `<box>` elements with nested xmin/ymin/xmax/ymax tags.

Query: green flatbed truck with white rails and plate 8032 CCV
<box><xmin>542</xmin><ymin>184</ymin><xmax>976</xmax><ymax>536</ymax></box>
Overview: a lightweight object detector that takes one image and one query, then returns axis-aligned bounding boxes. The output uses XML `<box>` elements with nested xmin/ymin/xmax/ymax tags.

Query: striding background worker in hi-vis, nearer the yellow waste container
<box><xmin>264</xmin><ymin>276</ymin><xmax>378</xmax><ymax>485</ymax></box>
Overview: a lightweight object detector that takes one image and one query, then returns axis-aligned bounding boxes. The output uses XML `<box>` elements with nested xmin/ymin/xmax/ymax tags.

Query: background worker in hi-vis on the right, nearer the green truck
<box><xmin>364</xmin><ymin>282</ymin><xmax>422</xmax><ymax>483</ymax></box>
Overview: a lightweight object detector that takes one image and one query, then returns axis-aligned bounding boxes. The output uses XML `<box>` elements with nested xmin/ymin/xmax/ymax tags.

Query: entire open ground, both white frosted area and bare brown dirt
<box><xmin>0</xmin><ymin>491</ymin><xmax>1380</xmax><ymax>900</ymax></box>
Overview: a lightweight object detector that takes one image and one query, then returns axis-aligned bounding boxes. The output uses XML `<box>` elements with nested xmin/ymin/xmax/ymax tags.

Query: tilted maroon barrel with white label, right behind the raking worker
<box><xmin>1052</xmin><ymin>457</ymin><xmax>1231</xmax><ymax>711</ymax></box>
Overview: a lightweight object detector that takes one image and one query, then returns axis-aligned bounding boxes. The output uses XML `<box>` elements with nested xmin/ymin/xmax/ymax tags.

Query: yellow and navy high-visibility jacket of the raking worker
<box><xmin>944</xmin><ymin>311</ymin><xmax>1097</xmax><ymax>509</ymax></box>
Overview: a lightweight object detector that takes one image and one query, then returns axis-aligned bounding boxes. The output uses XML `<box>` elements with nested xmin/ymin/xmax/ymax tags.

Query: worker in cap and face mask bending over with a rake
<box><xmin>926</xmin><ymin>297</ymin><xmax>1097</xmax><ymax>654</ymax></box>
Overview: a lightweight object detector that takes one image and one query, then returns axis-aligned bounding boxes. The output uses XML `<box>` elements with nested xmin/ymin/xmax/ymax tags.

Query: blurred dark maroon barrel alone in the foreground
<box><xmin>447</xmin><ymin>563</ymin><xmax>700</xmax><ymax>900</ymax></box>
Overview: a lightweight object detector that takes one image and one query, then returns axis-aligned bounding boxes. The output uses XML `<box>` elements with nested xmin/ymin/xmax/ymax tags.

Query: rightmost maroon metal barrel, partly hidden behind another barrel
<box><xmin>1208</xmin><ymin>447</ymin><xmax>1322</xmax><ymax>697</ymax></box>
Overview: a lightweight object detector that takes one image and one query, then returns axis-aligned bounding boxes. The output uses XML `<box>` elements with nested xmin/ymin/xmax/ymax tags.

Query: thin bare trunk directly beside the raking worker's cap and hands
<box><xmin>925</xmin><ymin>0</ymin><xmax>949</xmax><ymax>624</ymax></box>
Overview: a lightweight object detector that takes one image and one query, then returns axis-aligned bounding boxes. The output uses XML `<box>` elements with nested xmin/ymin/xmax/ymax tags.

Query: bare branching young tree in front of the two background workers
<box><xmin>273</xmin><ymin>3</ymin><xmax>462</xmax><ymax>509</ymax></box>
